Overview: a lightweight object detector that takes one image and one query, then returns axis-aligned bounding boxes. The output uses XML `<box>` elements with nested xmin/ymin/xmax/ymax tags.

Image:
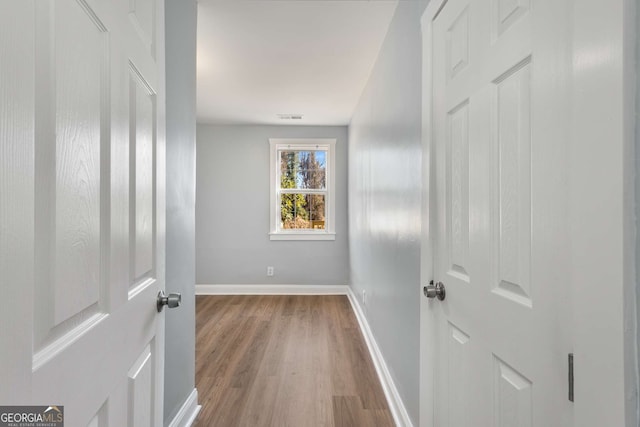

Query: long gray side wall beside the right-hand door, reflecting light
<box><xmin>349</xmin><ymin>1</ymin><xmax>426</xmax><ymax>425</ymax></box>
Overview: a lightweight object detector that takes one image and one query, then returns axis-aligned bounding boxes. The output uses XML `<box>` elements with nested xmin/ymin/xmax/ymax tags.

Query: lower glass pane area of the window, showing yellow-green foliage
<box><xmin>280</xmin><ymin>193</ymin><xmax>325</xmax><ymax>230</ymax></box>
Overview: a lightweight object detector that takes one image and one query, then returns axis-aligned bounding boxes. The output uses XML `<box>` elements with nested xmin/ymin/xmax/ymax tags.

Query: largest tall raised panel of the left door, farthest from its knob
<box><xmin>33</xmin><ymin>0</ymin><xmax>109</xmax><ymax>368</ymax></box>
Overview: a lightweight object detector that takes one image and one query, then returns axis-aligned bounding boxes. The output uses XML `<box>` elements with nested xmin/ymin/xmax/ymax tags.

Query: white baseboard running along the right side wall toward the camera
<box><xmin>347</xmin><ymin>288</ymin><xmax>413</xmax><ymax>427</ymax></box>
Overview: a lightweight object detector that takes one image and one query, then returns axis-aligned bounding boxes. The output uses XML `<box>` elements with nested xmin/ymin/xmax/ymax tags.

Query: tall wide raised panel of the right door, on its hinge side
<box><xmin>492</xmin><ymin>58</ymin><xmax>533</xmax><ymax>307</ymax></box>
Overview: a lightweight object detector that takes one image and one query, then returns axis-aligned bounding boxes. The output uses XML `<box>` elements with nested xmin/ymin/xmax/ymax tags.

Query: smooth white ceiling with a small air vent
<box><xmin>197</xmin><ymin>0</ymin><xmax>397</xmax><ymax>125</ymax></box>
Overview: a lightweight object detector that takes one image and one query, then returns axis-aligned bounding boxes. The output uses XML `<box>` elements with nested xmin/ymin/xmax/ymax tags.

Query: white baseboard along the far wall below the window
<box><xmin>196</xmin><ymin>285</ymin><xmax>349</xmax><ymax>295</ymax></box>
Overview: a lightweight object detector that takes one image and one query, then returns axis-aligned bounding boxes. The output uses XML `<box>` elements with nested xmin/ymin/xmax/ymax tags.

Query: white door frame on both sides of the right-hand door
<box><xmin>418</xmin><ymin>0</ymin><xmax>638</xmax><ymax>427</ymax></box>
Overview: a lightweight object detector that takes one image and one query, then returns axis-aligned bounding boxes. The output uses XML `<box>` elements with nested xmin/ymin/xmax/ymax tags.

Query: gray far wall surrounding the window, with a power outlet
<box><xmin>196</xmin><ymin>125</ymin><xmax>349</xmax><ymax>285</ymax></box>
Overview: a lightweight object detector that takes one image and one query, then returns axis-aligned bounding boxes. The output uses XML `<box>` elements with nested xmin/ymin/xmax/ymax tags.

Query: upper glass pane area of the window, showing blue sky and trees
<box><xmin>280</xmin><ymin>150</ymin><xmax>327</xmax><ymax>190</ymax></box>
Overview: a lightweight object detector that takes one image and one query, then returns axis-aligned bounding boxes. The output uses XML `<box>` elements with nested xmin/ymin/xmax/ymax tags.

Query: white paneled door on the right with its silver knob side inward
<box><xmin>422</xmin><ymin>0</ymin><xmax>573</xmax><ymax>427</ymax></box>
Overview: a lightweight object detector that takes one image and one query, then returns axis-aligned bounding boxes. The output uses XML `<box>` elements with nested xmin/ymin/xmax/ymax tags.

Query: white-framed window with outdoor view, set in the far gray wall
<box><xmin>269</xmin><ymin>139</ymin><xmax>336</xmax><ymax>240</ymax></box>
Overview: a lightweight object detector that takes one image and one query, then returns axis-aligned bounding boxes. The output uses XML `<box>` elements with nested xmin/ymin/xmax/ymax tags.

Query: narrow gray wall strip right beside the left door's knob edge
<box><xmin>164</xmin><ymin>0</ymin><xmax>196</xmax><ymax>425</ymax></box>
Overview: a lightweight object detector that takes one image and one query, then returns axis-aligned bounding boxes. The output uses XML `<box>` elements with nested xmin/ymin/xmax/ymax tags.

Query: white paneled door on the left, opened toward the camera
<box><xmin>0</xmin><ymin>0</ymin><xmax>165</xmax><ymax>427</ymax></box>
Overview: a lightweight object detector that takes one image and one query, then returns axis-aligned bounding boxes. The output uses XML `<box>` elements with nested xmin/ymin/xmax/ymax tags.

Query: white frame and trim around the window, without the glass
<box><xmin>269</xmin><ymin>138</ymin><xmax>336</xmax><ymax>240</ymax></box>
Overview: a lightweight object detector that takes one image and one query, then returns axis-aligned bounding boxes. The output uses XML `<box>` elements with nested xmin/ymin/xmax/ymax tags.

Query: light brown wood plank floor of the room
<box><xmin>194</xmin><ymin>295</ymin><xmax>394</xmax><ymax>427</ymax></box>
